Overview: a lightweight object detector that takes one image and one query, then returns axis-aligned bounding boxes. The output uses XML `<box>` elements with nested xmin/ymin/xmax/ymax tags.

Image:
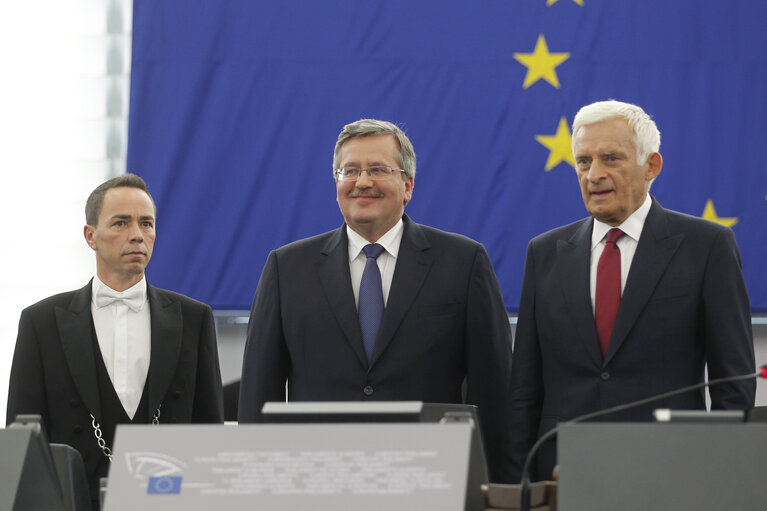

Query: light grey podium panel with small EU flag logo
<box><xmin>104</xmin><ymin>423</ymin><xmax>479</xmax><ymax>511</ymax></box>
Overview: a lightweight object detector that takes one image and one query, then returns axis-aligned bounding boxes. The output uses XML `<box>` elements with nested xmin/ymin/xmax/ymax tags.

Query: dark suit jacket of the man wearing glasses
<box><xmin>239</xmin><ymin>216</ymin><xmax>511</xmax><ymax>480</ymax></box>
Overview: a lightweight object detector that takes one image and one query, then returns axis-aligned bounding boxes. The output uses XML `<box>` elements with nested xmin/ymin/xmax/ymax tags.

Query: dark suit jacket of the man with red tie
<box><xmin>511</xmin><ymin>199</ymin><xmax>756</xmax><ymax>480</ymax></box>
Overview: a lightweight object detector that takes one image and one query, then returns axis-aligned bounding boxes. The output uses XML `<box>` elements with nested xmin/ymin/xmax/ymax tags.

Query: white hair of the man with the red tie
<box><xmin>572</xmin><ymin>99</ymin><xmax>660</xmax><ymax>165</ymax></box>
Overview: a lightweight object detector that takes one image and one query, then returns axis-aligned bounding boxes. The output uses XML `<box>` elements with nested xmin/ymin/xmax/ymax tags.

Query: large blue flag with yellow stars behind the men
<box><xmin>128</xmin><ymin>0</ymin><xmax>767</xmax><ymax>312</ymax></box>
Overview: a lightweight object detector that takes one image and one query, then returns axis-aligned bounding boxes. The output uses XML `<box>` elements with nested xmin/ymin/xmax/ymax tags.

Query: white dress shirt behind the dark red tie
<box><xmin>590</xmin><ymin>193</ymin><xmax>652</xmax><ymax>314</ymax></box>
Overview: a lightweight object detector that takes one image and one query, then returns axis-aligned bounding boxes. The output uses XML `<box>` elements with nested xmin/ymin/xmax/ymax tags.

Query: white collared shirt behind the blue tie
<box><xmin>346</xmin><ymin>219</ymin><xmax>405</xmax><ymax>307</ymax></box>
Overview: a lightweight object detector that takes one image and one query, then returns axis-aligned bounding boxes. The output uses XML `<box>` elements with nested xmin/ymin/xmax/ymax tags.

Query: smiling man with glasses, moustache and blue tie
<box><xmin>239</xmin><ymin>119</ymin><xmax>511</xmax><ymax>480</ymax></box>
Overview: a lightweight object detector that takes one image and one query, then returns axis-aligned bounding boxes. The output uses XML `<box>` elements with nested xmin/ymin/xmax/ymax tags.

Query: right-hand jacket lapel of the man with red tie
<box><xmin>605</xmin><ymin>198</ymin><xmax>684</xmax><ymax>364</ymax></box>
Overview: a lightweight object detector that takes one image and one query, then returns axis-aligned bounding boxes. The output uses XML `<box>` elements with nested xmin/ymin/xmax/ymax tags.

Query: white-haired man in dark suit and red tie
<box><xmin>511</xmin><ymin>101</ymin><xmax>755</xmax><ymax>480</ymax></box>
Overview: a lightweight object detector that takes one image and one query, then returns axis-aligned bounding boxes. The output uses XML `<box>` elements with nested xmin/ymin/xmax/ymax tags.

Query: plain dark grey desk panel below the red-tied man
<box><xmin>557</xmin><ymin>423</ymin><xmax>767</xmax><ymax>511</ymax></box>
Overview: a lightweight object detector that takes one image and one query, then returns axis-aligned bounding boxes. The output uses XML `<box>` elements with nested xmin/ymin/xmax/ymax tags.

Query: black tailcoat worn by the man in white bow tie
<box><xmin>7</xmin><ymin>283</ymin><xmax>224</xmax><ymax>498</ymax></box>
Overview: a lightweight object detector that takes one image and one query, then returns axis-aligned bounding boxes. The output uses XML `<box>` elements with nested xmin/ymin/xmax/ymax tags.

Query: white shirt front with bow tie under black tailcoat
<box><xmin>91</xmin><ymin>276</ymin><xmax>152</xmax><ymax>419</ymax></box>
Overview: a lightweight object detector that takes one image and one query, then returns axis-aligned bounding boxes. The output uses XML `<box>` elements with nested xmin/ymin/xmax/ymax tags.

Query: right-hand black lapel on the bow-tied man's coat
<box><xmin>147</xmin><ymin>284</ymin><xmax>182</xmax><ymax>413</ymax></box>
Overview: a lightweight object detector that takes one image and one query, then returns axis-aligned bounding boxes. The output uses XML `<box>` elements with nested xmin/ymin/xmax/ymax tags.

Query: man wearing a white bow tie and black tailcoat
<box><xmin>7</xmin><ymin>174</ymin><xmax>223</xmax><ymax>509</ymax></box>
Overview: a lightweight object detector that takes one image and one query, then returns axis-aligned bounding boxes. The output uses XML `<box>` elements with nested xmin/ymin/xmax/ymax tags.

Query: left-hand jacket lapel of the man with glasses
<box><xmin>317</xmin><ymin>228</ymin><xmax>368</xmax><ymax>367</ymax></box>
